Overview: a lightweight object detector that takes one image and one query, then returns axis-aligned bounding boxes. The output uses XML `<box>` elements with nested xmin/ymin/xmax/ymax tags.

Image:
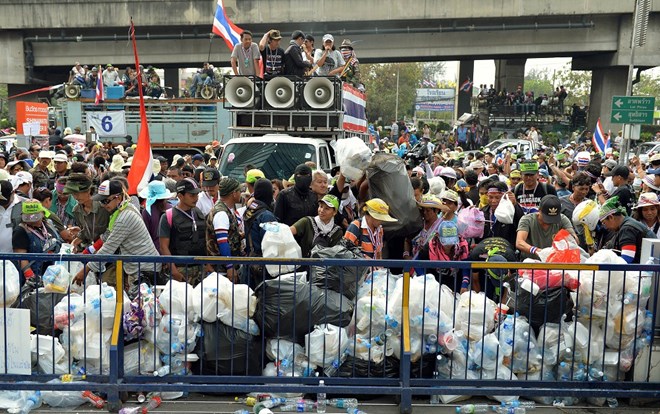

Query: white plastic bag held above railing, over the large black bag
<box><xmin>260</xmin><ymin>222</ymin><xmax>302</xmax><ymax>277</ymax></box>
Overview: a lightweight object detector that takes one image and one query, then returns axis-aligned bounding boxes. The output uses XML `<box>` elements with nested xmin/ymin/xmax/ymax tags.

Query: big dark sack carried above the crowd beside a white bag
<box><xmin>367</xmin><ymin>153</ymin><xmax>423</xmax><ymax>240</ymax></box>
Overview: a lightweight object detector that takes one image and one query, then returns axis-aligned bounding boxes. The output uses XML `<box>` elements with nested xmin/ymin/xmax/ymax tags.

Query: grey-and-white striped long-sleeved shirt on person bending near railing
<box><xmin>89</xmin><ymin>203</ymin><xmax>161</xmax><ymax>275</ymax></box>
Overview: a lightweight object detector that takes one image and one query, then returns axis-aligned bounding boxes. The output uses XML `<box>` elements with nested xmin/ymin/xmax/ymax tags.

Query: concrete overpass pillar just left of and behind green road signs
<box><xmin>587</xmin><ymin>66</ymin><xmax>628</xmax><ymax>136</ymax></box>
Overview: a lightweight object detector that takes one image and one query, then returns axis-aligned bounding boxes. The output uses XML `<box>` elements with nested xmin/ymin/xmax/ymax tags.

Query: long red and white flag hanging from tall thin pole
<box><xmin>128</xmin><ymin>19</ymin><xmax>154</xmax><ymax>195</ymax></box>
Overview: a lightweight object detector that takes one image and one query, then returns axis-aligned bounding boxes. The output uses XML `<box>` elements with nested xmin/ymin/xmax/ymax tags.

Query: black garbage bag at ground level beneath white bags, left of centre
<box><xmin>193</xmin><ymin>321</ymin><xmax>263</xmax><ymax>376</ymax></box>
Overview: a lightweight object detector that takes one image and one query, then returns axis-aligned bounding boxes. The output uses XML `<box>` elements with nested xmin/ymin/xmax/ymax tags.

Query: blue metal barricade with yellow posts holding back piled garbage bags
<box><xmin>0</xmin><ymin>251</ymin><xmax>660</xmax><ymax>412</ymax></box>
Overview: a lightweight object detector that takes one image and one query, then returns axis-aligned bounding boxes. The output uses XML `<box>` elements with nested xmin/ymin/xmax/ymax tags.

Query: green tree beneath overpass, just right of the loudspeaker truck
<box><xmin>360</xmin><ymin>63</ymin><xmax>423</xmax><ymax>123</ymax></box>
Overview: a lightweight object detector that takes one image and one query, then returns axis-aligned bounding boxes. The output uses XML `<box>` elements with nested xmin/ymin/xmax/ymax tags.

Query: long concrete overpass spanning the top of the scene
<box><xmin>0</xmin><ymin>0</ymin><xmax>660</xmax><ymax>129</ymax></box>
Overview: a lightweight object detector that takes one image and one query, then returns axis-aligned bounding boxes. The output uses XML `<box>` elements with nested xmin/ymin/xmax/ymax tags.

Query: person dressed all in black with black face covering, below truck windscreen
<box><xmin>275</xmin><ymin>164</ymin><xmax>318</xmax><ymax>226</ymax></box>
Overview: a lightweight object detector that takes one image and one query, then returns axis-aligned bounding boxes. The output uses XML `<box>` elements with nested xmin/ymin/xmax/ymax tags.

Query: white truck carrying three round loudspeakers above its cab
<box><xmin>219</xmin><ymin>77</ymin><xmax>370</xmax><ymax>180</ymax></box>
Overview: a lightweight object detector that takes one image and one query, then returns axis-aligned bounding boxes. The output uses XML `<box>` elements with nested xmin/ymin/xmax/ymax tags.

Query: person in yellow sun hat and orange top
<box><xmin>344</xmin><ymin>198</ymin><xmax>397</xmax><ymax>259</ymax></box>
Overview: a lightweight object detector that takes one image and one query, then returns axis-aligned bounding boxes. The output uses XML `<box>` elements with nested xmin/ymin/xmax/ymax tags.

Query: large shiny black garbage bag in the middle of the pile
<box><xmin>254</xmin><ymin>277</ymin><xmax>353</xmax><ymax>345</ymax></box>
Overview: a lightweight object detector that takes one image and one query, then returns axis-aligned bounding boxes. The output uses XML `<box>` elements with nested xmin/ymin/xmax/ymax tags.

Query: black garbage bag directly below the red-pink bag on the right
<box><xmin>509</xmin><ymin>281</ymin><xmax>574</xmax><ymax>335</ymax></box>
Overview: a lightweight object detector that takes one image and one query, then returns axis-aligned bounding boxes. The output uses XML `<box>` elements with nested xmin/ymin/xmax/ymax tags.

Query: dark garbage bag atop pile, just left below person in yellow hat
<box><xmin>309</xmin><ymin>245</ymin><xmax>368</xmax><ymax>300</ymax></box>
